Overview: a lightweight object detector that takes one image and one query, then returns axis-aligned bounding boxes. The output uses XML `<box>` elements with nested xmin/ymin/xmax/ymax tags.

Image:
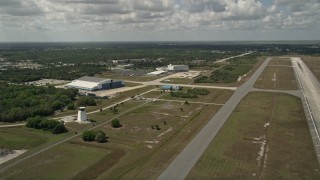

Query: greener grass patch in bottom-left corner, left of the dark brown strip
<box><xmin>1</xmin><ymin>143</ymin><xmax>111</xmax><ymax>179</ymax></box>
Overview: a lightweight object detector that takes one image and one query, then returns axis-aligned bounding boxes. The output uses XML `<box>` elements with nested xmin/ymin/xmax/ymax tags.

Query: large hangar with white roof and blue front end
<box><xmin>65</xmin><ymin>76</ymin><xmax>124</xmax><ymax>91</ymax></box>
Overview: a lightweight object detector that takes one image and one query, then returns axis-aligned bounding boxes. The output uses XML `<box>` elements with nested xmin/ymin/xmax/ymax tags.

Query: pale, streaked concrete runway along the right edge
<box><xmin>291</xmin><ymin>57</ymin><xmax>320</xmax><ymax>163</ymax></box>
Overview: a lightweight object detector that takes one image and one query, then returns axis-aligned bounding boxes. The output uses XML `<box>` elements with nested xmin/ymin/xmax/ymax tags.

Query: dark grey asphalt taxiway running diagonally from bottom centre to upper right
<box><xmin>158</xmin><ymin>58</ymin><xmax>271</xmax><ymax>180</ymax></box>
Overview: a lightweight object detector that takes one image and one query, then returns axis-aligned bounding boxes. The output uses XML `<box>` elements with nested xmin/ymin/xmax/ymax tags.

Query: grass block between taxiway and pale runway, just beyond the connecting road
<box><xmin>254</xmin><ymin>66</ymin><xmax>298</xmax><ymax>90</ymax></box>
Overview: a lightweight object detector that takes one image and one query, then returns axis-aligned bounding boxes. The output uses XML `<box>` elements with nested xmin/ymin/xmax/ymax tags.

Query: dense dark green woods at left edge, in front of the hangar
<box><xmin>0</xmin><ymin>83</ymin><xmax>78</xmax><ymax>122</ymax></box>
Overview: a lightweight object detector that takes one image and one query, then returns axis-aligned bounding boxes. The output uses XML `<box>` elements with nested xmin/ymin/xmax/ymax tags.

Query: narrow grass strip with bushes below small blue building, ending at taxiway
<box><xmin>144</xmin><ymin>88</ymin><xmax>233</xmax><ymax>104</ymax></box>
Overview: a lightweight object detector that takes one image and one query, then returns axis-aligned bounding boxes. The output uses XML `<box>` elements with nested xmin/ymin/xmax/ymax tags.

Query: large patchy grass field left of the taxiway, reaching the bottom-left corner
<box><xmin>0</xmin><ymin>101</ymin><xmax>225</xmax><ymax>179</ymax></box>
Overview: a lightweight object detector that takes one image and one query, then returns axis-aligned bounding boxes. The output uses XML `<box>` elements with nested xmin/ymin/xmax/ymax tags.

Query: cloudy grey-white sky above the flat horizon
<box><xmin>0</xmin><ymin>0</ymin><xmax>320</xmax><ymax>42</ymax></box>
